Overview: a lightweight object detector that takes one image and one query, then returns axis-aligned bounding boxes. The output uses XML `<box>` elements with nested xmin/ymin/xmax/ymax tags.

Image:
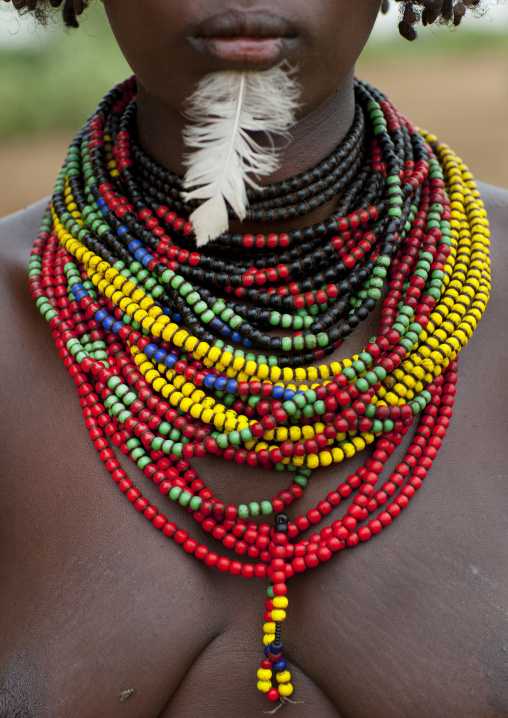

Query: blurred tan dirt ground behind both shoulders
<box><xmin>0</xmin><ymin>51</ymin><xmax>508</xmax><ymax>217</ymax></box>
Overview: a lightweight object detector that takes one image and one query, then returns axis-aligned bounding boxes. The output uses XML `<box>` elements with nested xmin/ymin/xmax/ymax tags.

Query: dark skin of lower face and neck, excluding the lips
<box><xmin>105</xmin><ymin>0</ymin><xmax>379</xmax><ymax>177</ymax></box>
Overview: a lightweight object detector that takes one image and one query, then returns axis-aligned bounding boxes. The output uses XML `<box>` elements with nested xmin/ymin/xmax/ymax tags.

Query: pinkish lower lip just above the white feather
<box><xmin>205</xmin><ymin>35</ymin><xmax>284</xmax><ymax>65</ymax></box>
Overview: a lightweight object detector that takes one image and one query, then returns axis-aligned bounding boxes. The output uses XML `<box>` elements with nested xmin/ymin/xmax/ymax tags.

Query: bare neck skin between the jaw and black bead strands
<box><xmin>137</xmin><ymin>71</ymin><xmax>355</xmax><ymax>233</ymax></box>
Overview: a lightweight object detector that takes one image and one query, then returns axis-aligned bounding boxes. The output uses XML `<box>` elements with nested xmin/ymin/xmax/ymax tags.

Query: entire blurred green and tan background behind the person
<box><xmin>0</xmin><ymin>0</ymin><xmax>508</xmax><ymax>217</ymax></box>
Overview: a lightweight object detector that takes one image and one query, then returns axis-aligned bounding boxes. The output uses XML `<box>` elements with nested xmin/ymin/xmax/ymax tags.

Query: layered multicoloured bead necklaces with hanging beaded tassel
<box><xmin>30</xmin><ymin>78</ymin><xmax>490</xmax><ymax>702</ymax></box>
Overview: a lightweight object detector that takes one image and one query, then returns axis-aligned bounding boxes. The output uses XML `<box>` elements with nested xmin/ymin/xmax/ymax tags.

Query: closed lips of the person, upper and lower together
<box><xmin>189</xmin><ymin>10</ymin><xmax>298</xmax><ymax>69</ymax></box>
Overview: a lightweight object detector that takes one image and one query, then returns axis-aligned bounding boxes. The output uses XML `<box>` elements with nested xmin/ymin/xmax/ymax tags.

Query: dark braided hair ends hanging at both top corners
<box><xmin>5</xmin><ymin>0</ymin><xmax>490</xmax><ymax>40</ymax></box>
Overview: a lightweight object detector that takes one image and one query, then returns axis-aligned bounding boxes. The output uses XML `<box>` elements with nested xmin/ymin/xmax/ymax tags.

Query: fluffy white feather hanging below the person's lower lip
<box><xmin>182</xmin><ymin>66</ymin><xmax>300</xmax><ymax>247</ymax></box>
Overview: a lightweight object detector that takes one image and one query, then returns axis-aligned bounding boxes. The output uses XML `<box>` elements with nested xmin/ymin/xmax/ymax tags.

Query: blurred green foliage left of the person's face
<box><xmin>0</xmin><ymin>5</ymin><xmax>131</xmax><ymax>139</ymax></box>
